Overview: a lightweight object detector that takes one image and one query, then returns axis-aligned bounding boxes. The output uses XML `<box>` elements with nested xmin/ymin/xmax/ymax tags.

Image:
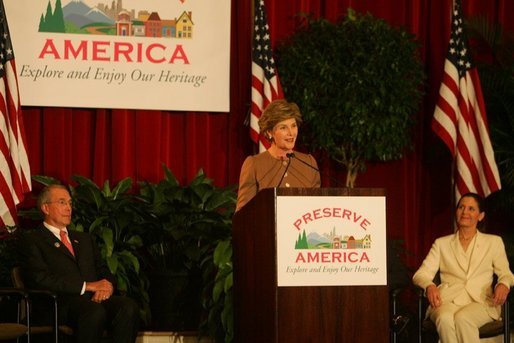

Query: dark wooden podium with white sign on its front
<box><xmin>232</xmin><ymin>188</ymin><xmax>390</xmax><ymax>343</ymax></box>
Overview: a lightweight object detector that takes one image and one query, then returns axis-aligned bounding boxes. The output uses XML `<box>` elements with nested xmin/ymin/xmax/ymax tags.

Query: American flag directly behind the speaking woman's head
<box><xmin>250</xmin><ymin>0</ymin><xmax>284</xmax><ymax>152</ymax></box>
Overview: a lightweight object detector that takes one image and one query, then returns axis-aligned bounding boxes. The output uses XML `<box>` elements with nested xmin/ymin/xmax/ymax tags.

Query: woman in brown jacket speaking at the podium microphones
<box><xmin>236</xmin><ymin>99</ymin><xmax>321</xmax><ymax>211</ymax></box>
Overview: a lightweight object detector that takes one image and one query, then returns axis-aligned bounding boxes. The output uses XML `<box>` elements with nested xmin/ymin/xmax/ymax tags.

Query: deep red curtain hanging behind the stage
<box><xmin>21</xmin><ymin>0</ymin><xmax>514</xmax><ymax>265</ymax></box>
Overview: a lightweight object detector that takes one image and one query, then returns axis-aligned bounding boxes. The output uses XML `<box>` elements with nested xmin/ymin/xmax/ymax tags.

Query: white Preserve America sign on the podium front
<box><xmin>276</xmin><ymin>196</ymin><xmax>387</xmax><ymax>287</ymax></box>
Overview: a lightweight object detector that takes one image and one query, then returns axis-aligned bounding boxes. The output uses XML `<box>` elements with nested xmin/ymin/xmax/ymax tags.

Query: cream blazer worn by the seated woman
<box><xmin>412</xmin><ymin>232</ymin><xmax>514</xmax><ymax>319</ymax></box>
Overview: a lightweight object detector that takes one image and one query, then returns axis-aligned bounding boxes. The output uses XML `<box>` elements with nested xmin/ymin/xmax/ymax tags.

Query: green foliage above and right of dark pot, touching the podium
<box><xmin>140</xmin><ymin>166</ymin><xmax>236</xmax><ymax>342</ymax></box>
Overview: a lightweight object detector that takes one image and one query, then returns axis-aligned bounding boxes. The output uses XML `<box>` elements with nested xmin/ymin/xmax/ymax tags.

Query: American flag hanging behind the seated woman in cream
<box><xmin>432</xmin><ymin>0</ymin><xmax>501</xmax><ymax>200</ymax></box>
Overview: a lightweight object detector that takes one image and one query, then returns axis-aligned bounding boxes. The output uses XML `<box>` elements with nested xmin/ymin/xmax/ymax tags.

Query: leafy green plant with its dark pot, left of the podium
<box><xmin>139</xmin><ymin>166</ymin><xmax>236</xmax><ymax>338</ymax></box>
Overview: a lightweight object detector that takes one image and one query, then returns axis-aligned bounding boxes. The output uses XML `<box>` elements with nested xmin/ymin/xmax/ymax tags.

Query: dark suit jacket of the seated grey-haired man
<box><xmin>18</xmin><ymin>225</ymin><xmax>115</xmax><ymax>319</ymax></box>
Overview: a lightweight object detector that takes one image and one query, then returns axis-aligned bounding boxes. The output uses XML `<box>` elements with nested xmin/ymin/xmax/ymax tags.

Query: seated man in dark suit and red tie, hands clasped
<box><xmin>18</xmin><ymin>185</ymin><xmax>139</xmax><ymax>343</ymax></box>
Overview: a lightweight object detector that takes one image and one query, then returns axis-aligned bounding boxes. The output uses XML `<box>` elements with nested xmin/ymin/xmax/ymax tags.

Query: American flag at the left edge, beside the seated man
<box><xmin>0</xmin><ymin>0</ymin><xmax>31</xmax><ymax>226</ymax></box>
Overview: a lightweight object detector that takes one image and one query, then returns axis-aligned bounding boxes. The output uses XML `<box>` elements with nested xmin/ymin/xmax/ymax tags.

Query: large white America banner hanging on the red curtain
<box><xmin>4</xmin><ymin>0</ymin><xmax>230</xmax><ymax>112</ymax></box>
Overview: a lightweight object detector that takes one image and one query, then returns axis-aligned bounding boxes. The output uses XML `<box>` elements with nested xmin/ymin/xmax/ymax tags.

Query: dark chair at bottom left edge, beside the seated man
<box><xmin>0</xmin><ymin>288</ymin><xmax>30</xmax><ymax>342</ymax></box>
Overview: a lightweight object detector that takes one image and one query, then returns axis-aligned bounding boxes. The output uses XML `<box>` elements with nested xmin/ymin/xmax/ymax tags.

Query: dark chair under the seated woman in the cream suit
<box><xmin>418</xmin><ymin>288</ymin><xmax>512</xmax><ymax>343</ymax></box>
